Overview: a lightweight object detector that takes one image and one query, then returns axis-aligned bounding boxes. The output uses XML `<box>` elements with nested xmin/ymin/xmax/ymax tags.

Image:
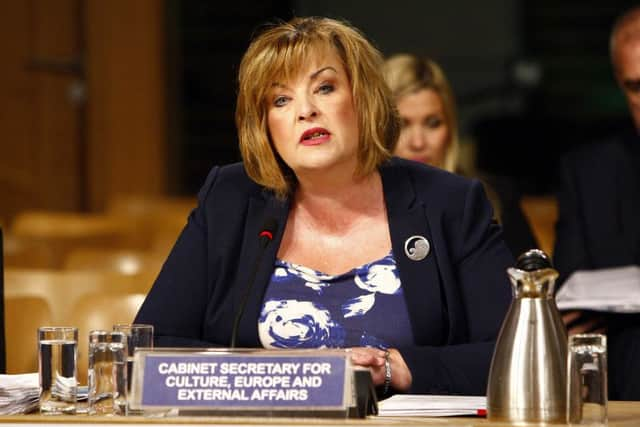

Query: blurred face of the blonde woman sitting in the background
<box><xmin>394</xmin><ymin>89</ymin><xmax>451</xmax><ymax>167</ymax></box>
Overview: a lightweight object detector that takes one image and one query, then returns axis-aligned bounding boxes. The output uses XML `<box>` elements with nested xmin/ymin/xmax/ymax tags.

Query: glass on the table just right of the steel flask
<box><xmin>567</xmin><ymin>334</ymin><xmax>608</xmax><ymax>425</ymax></box>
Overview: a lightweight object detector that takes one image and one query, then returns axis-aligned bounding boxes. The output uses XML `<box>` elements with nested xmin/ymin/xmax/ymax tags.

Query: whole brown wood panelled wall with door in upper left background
<box><xmin>0</xmin><ymin>0</ymin><xmax>166</xmax><ymax>223</ymax></box>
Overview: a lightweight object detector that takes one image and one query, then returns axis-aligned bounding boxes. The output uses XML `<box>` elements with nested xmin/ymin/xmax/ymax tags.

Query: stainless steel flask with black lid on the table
<box><xmin>487</xmin><ymin>249</ymin><xmax>567</xmax><ymax>423</ymax></box>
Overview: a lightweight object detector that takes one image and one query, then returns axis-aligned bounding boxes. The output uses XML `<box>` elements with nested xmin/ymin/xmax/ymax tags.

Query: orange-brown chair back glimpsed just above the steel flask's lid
<box><xmin>520</xmin><ymin>196</ymin><xmax>558</xmax><ymax>256</ymax></box>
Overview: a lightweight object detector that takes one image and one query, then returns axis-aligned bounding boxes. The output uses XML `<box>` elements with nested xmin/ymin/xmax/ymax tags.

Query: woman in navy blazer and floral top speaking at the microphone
<box><xmin>136</xmin><ymin>18</ymin><xmax>512</xmax><ymax>394</ymax></box>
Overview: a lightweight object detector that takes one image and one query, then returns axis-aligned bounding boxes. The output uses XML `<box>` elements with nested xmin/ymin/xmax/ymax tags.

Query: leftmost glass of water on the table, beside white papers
<box><xmin>38</xmin><ymin>326</ymin><xmax>78</xmax><ymax>414</ymax></box>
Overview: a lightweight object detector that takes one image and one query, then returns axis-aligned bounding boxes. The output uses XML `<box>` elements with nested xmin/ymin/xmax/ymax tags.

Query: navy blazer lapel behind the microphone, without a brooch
<box><xmin>233</xmin><ymin>193</ymin><xmax>289</xmax><ymax>347</ymax></box>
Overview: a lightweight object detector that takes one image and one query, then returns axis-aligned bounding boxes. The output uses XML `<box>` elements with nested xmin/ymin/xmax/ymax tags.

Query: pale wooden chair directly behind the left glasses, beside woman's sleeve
<box><xmin>69</xmin><ymin>292</ymin><xmax>145</xmax><ymax>384</ymax></box>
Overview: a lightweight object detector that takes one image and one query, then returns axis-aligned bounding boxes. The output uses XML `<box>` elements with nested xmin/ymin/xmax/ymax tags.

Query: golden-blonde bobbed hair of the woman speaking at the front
<box><xmin>236</xmin><ymin>17</ymin><xmax>400</xmax><ymax>197</ymax></box>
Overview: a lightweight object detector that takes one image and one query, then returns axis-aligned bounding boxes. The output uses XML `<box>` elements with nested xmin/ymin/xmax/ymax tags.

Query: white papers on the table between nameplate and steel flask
<box><xmin>378</xmin><ymin>394</ymin><xmax>487</xmax><ymax>417</ymax></box>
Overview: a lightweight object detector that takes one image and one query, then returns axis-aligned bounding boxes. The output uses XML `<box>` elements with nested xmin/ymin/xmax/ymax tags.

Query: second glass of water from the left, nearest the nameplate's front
<box><xmin>89</xmin><ymin>330</ymin><xmax>127</xmax><ymax>415</ymax></box>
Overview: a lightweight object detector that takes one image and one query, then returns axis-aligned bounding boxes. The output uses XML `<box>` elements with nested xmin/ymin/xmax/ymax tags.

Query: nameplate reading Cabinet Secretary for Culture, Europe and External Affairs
<box><xmin>130</xmin><ymin>349</ymin><xmax>352</xmax><ymax>410</ymax></box>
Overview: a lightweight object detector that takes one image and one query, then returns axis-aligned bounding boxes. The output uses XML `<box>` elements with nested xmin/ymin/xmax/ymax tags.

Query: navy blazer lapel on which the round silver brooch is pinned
<box><xmin>380</xmin><ymin>166</ymin><xmax>447</xmax><ymax>345</ymax></box>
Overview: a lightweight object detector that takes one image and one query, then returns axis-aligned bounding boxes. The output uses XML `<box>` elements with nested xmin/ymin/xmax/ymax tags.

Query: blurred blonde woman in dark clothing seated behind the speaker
<box><xmin>384</xmin><ymin>54</ymin><xmax>537</xmax><ymax>254</ymax></box>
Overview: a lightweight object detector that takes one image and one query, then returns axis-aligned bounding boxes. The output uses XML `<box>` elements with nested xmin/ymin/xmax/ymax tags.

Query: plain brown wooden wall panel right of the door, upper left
<box><xmin>86</xmin><ymin>0</ymin><xmax>166</xmax><ymax>210</ymax></box>
